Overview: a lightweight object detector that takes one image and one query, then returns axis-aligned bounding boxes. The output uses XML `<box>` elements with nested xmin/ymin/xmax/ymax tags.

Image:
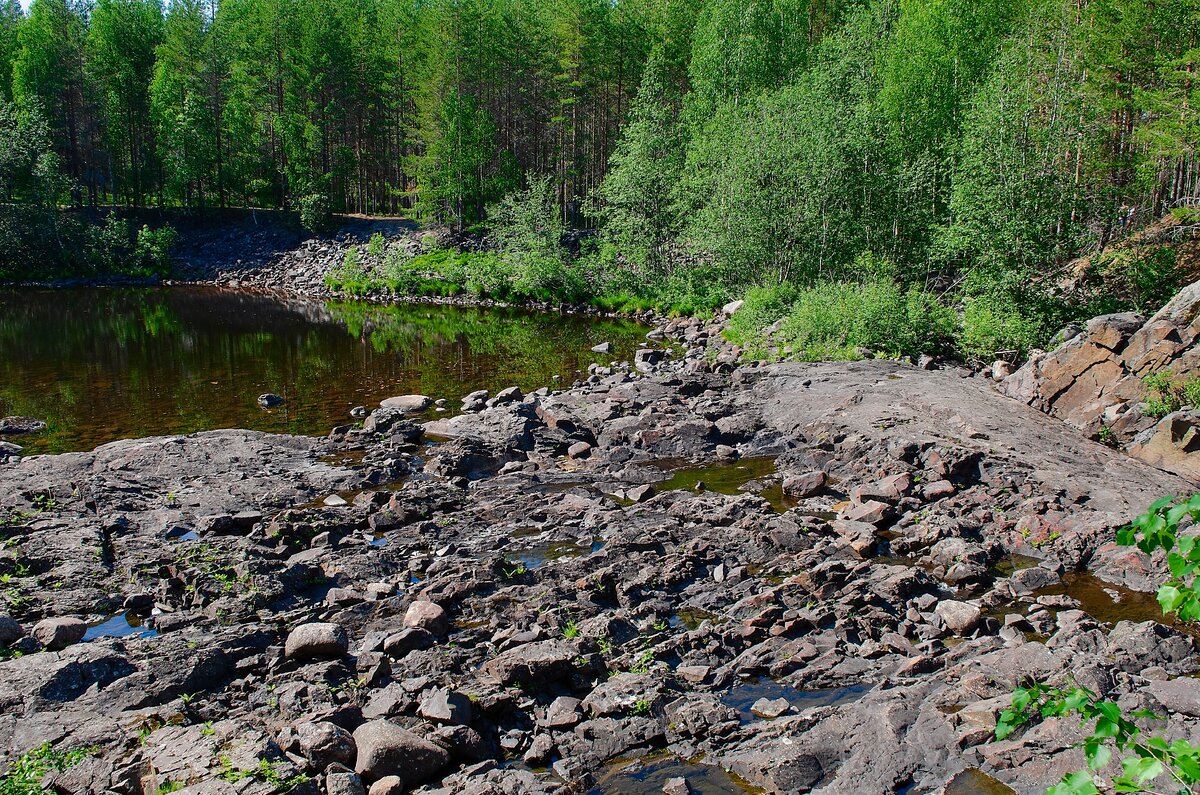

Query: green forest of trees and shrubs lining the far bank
<box><xmin>0</xmin><ymin>0</ymin><xmax>1200</xmax><ymax>359</ymax></box>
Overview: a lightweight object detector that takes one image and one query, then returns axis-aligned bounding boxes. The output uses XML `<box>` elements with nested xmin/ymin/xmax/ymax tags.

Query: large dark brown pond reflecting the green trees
<box><xmin>0</xmin><ymin>287</ymin><xmax>646</xmax><ymax>454</ymax></box>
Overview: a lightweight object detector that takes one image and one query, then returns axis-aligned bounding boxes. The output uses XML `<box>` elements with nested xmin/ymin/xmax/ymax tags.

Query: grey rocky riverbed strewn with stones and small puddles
<box><xmin>0</xmin><ymin>312</ymin><xmax>1200</xmax><ymax>795</ymax></box>
